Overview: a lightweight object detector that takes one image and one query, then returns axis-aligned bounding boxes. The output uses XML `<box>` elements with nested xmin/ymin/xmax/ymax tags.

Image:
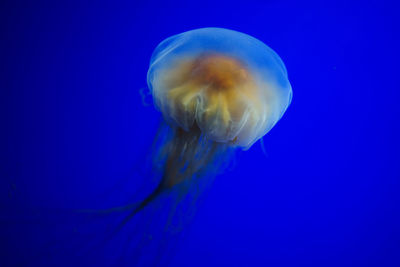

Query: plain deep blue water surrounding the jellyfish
<box><xmin>0</xmin><ymin>1</ymin><xmax>400</xmax><ymax>266</ymax></box>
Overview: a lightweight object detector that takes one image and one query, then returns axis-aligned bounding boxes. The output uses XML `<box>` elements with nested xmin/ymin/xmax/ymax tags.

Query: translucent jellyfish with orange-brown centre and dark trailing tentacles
<box><xmin>119</xmin><ymin>28</ymin><xmax>292</xmax><ymax>228</ymax></box>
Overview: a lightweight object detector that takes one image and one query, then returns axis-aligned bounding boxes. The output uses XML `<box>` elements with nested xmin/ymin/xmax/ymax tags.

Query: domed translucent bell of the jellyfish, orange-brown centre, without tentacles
<box><xmin>147</xmin><ymin>28</ymin><xmax>292</xmax><ymax>149</ymax></box>
